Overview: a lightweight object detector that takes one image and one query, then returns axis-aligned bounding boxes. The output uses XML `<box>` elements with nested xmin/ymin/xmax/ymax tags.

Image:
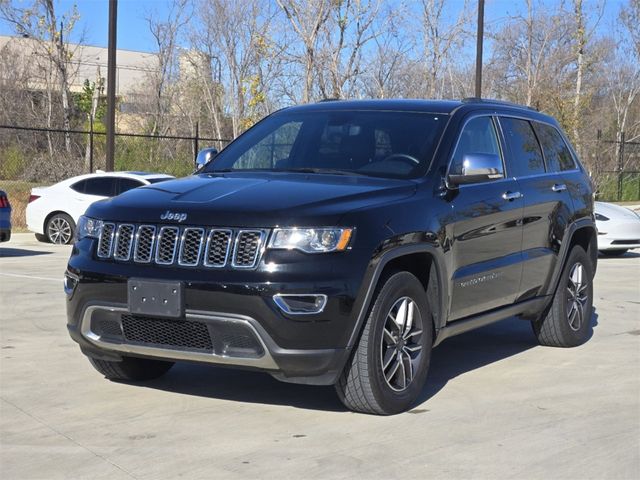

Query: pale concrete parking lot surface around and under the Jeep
<box><xmin>0</xmin><ymin>234</ymin><xmax>640</xmax><ymax>479</ymax></box>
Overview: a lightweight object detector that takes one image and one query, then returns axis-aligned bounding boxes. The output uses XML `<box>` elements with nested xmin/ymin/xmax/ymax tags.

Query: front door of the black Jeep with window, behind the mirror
<box><xmin>447</xmin><ymin>115</ymin><xmax>523</xmax><ymax>320</ymax></box>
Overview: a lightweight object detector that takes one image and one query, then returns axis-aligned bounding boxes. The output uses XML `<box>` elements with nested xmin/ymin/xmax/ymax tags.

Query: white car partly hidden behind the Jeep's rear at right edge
<box><xmin>595</xmin><ymin>202</ymin><xmax>640</xmax><ymax>256</ymax></box>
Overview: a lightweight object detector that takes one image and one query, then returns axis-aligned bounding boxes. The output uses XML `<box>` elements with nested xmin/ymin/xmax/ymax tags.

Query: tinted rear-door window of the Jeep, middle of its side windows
<box><xmin>500</xmin><ymin>117</ymin><xmax>545</xmax><ymax>177</ymax></box>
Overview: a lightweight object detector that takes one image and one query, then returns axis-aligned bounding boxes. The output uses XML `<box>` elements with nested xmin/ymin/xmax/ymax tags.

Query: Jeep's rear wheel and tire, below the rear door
<box><xmin>533</xmin><ymin>246</ymin><xmax>593</xmax><ymax>347</ymax></box>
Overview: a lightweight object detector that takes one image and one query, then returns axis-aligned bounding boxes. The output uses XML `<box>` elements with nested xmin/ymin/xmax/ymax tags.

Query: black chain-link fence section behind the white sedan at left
<box><xmin>0</xmin><ymin>125</ymin><xmax>228</xmax><ymax>229</ymax></box>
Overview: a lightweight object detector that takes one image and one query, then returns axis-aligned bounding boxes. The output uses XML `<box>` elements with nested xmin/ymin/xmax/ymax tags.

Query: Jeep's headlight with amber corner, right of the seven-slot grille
<box><xmin>269</xmin><ymin>228</ymin><xmax>353</xmax><ymax>253</ymax></box>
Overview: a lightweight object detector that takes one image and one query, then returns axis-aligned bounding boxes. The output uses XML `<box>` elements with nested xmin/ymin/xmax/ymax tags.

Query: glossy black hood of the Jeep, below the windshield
<box><xmin>87</xmin><ymin>172</ymin><xmax>416</xmax><ymax>227</ymax></box>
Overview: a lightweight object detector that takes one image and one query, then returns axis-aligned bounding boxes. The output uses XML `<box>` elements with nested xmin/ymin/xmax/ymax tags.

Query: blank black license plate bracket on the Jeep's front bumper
<box><xmin>127</xmin><ymin>278</ymin><xmax>184</xmax><ymax>318</ymax></box>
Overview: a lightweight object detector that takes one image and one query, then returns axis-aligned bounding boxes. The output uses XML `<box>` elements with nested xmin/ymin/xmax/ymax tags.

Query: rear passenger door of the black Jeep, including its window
<box><xmin>500</xmin><ymin>116</ymin><xmax>573</xmax><ymax>301</ymax></box>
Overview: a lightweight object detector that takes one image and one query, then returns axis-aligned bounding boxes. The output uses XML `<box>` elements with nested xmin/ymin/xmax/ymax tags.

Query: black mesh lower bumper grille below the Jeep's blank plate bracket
<box><xmin>122</xmin><ymin>315</ymin><xmax>213</xmax><ymax>353</ymax></box>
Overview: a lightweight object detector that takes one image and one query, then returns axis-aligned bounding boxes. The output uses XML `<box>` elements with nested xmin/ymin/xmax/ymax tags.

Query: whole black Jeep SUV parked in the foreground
<box><xmin>65</xmin><ymin>99</ymin><xmax>597</xmax><ymax>414</ymax></box>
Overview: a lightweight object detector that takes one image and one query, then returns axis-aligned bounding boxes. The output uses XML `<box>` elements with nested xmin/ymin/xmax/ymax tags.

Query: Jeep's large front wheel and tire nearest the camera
<box><xmin>335</xmin><ymin>272</ymin><xmax>433</xmax><ymax>415</ymax></box>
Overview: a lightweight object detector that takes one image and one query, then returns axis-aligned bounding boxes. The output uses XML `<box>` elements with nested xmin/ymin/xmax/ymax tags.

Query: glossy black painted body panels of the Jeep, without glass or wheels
<box><xmin>67</xmin><ymin>101</ymin><xmax>595</xmax><ymax>384</ymax></box>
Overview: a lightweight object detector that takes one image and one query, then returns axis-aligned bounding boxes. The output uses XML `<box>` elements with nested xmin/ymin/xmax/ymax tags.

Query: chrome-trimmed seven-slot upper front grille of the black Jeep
<box><xmin>96</xmin><ymin>223</ymin><xmax>267</xmax><ymax>269</ymax></box>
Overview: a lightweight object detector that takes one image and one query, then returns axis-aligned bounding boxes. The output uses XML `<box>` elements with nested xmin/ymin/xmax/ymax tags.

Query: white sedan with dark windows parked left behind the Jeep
<box><xmin>27</xmin><ymin>171</ymin><xmax>174</xmax><ymax>244</ymax></box>
